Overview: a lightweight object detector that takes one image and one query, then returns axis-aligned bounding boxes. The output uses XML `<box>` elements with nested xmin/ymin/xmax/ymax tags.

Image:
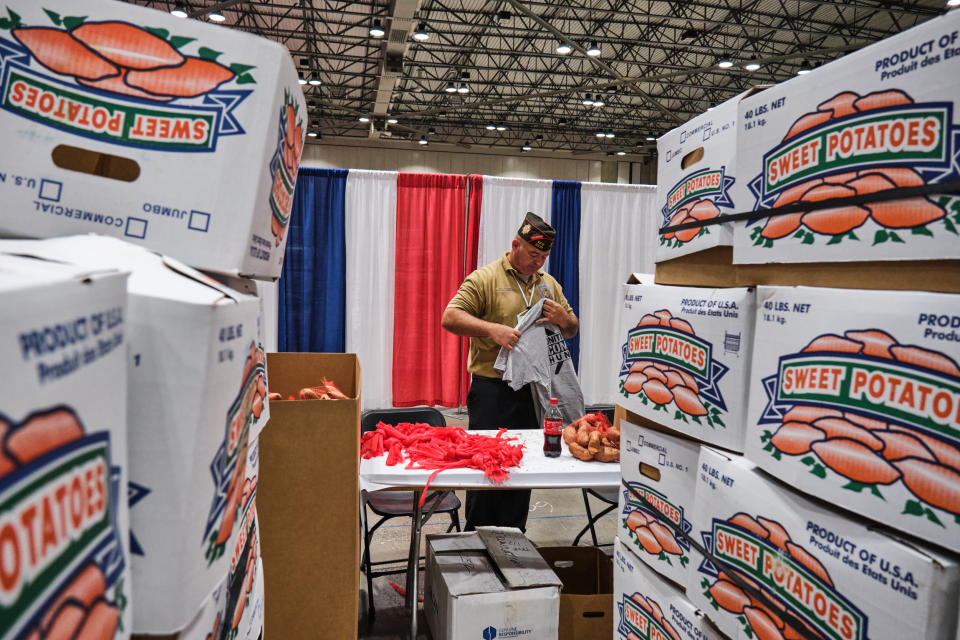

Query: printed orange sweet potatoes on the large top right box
<box><xmin>751</xmin><ymin>90</ymin><xmax>952</xmax><ymax>247</ymax></box>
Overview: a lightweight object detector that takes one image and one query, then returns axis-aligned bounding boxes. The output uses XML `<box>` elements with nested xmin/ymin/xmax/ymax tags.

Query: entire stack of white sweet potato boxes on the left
<box><xmin>0</xmin><ymin>0</ymin><xmax>306</xmax><ymax>639</ymax></box>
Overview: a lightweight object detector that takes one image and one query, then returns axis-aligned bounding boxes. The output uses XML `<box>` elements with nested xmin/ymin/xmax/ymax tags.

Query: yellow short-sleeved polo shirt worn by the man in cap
<box><xmin>447</xmin><ymin>252</ymin><xmax>573</xmax><ymax>378</ymax></box>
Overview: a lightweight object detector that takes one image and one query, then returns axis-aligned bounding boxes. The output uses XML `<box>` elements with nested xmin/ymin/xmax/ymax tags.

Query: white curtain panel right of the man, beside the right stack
<box><xmin>576</xmin><ymin>182</ymin><xmax>659</xmax><ymax>405</ymax></box>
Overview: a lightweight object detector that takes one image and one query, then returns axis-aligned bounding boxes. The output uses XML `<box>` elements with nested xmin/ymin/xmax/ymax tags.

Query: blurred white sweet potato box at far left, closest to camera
<box><xmin>0</xmin><ymin>250</ymin><xmax>130</xmax><ymax>638</ymax></box>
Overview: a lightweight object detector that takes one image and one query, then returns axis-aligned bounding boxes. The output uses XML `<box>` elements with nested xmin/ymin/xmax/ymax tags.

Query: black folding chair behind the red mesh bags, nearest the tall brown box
<box><xmin>360</xmin><ymin>407</ymin><xmax>460</xmax><ymax>618</ymax></box>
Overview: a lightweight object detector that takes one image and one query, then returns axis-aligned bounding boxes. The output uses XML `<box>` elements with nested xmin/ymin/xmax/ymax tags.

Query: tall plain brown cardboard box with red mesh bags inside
<box><xmin>257</xmin><ymin>353</ymin><xmax>360</xmax><ymax>640</ymax></box>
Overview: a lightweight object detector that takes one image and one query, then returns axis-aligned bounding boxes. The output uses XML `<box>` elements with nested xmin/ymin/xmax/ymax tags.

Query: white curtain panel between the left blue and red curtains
<box><xmin>344</xmin><ymin>169</ymin><xmax>397</xmax><ymax>410</ymax></box>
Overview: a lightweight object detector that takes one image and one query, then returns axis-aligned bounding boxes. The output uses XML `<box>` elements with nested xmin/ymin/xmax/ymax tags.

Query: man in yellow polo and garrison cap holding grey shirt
<box><xmin>440</xmin><ymin>213</ymin><xmax>580</xmax><ymax>531</ymax></box>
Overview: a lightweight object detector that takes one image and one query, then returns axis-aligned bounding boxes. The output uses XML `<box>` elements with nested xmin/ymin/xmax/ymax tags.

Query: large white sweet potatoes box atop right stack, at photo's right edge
<box><xmin>734</xmin><ymin>12</ymin><xmax>960</xmax><ymax>263</ymax></box>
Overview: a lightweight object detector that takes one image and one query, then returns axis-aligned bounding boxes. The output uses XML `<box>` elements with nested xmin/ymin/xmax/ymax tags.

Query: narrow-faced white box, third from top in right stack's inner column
<box><xmin>617</xmin><ymin>420</ymin><xmax>700</xmax><ymax>589</ymax></box>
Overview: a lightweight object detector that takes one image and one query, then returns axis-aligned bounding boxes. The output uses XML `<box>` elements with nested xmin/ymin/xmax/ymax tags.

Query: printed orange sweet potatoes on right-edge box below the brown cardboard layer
<box><xmin>761</xmin><ymin>329</ymin><xmax>960</xmax><ymax>522</ymax></box>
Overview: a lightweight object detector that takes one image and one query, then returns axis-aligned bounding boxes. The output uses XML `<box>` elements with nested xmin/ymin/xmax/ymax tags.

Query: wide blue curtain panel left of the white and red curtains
<box><xmin>277</xmin><ymin>167</ymin><xmax>347</xmax><ymax>353</ymax></box>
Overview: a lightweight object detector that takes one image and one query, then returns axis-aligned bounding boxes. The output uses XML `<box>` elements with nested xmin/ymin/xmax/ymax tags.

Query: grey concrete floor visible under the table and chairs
<box><xmin>358</xmin><ymin>411</ymin><xmax>617</xmax><ymax>640</ymax></box>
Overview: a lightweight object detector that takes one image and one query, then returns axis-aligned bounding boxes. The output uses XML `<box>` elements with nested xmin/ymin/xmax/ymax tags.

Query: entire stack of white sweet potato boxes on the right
<box><xmin>614</xmin><ymin>12</ymin><xmax>960</xmax><ymax>640</ymax></box>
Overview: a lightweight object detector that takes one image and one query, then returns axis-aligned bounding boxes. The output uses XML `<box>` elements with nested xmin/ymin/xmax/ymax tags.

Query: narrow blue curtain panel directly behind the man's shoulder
<box><xmin>549</xmin><ymin>180</ymin><xmax>580</xmax><ymax>369</ymax></box>
